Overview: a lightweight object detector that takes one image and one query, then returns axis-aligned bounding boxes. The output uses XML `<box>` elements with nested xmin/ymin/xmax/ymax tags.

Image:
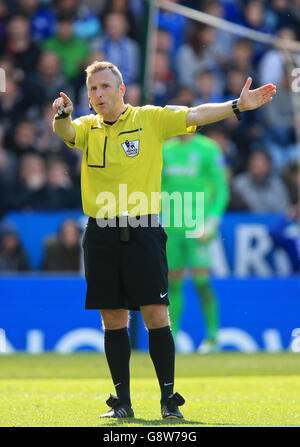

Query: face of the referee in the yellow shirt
<box><xmin>87</xmin><ymin>69</ymin><xmax>125</xmax><ymax>121</ymax></box>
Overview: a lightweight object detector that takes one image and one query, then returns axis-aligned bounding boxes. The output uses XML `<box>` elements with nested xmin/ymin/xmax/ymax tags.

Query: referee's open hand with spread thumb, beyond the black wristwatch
<box><xmin>237</xmin><ymin>77</ymin><xmax>276</xmax><ymax>112</ymax></box>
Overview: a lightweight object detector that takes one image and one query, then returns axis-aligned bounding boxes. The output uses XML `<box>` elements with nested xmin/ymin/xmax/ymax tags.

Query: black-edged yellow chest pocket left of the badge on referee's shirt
<box><xmin>86</xmin><ymin>127</ymin><xmax>107</xmax><ymax>168</ymax></box>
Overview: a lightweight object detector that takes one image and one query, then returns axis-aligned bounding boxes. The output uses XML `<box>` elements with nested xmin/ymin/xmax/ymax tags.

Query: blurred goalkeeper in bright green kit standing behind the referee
<box><xmin>162</xmin><ymin>134</ymin><xmax>229</xmax><ymax>354</ymax></box>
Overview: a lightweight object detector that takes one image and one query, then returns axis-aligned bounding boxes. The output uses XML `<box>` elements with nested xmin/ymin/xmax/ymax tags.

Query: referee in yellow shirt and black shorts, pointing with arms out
<box><xmin>53</xmin><ymin>61</ymin><xmax>276</xmax><ymax>419</ymax></box>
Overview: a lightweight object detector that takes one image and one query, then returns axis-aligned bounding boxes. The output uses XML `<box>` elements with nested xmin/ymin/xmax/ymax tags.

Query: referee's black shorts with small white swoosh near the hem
<box><xmin>82</xmin><ymin>216</ymin><xmax>169</xmax><ymax>310</ymax></box>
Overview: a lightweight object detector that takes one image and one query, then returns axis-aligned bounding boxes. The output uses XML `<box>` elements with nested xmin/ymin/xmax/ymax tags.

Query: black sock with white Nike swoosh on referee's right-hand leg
<box><xmin>148</xmin><ymin>326</ymin><xmax>175</xmax><ymax>400</ymax></box>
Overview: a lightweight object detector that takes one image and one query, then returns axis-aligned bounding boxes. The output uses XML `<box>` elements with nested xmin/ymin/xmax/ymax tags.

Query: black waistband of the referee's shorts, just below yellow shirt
<box><xmin>88</xmin><ymin>214</ymin><xmax>160</xmax><ymax>228</ymax></box>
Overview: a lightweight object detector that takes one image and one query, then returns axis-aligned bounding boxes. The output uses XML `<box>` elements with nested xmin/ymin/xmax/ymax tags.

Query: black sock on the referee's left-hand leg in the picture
<box><xmin>104</xmin><ymin>327</ymin><xmax>131</xmax><ymax>404</ymax></box>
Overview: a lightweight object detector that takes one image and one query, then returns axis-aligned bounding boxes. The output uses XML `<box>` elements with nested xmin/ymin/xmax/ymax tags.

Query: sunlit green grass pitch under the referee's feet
<box><xmin>0</xmin><ymin>352</ymin><xmax>300</xmax><ymax>427</ymax></box>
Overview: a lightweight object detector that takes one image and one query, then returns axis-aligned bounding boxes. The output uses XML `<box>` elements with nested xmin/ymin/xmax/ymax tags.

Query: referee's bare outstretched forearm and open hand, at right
<box><xmin>186</xmin><ymin>77</ymin><xmax>276</xmax><ymax>127</ymax></box>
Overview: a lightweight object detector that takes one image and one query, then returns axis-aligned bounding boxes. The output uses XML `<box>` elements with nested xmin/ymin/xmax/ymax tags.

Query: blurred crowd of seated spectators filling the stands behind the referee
<box><xmin>0</xmin><ymin>0</ymin><xmax>300</xmax><ymax>272</ymax></box>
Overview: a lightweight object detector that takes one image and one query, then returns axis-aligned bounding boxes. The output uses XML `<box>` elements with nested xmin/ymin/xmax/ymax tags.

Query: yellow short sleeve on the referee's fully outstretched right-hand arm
<box><xmin>151</xmin><ymin>105</ymin><xmax>197</xmax><ymax>140</ymax></box>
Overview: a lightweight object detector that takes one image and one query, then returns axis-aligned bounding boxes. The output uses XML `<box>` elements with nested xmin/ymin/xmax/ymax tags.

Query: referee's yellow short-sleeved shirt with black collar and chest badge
<box><xmin>65</xmin><ymin>105</ymin><xmax>196</xmax><ymax>218</ymax></box>
